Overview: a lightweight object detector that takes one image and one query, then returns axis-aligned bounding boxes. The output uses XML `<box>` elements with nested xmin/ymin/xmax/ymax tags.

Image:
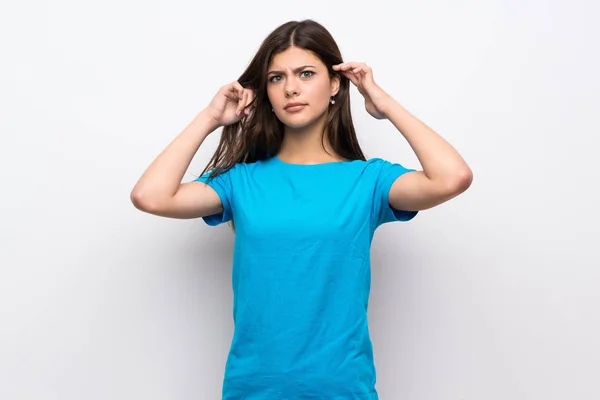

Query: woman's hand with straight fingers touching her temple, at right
<box><xmin>332</xmin><ymin>62</ymin><xmax>391</xmax><ymax>119</ymax></box>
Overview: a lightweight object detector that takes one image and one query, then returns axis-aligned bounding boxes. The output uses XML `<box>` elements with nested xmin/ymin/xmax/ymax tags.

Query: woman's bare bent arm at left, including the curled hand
<box><xmin>130</xmin><ymin>82</ymin><xmax>254</xmax><ymax>218</ymax></box>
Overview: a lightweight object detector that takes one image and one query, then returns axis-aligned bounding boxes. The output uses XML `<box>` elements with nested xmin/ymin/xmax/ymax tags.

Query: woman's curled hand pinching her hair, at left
<box><xmin>204</xmin><ymin>81</ymin><xmax>254</xmax><ymax>127</ymax></box>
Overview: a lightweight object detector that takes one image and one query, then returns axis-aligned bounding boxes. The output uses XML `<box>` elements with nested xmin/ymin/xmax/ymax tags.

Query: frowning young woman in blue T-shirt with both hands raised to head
<box><xmin>131</xmin><ymin>20</ymin><xmax>472</xmax><ymax>400</ymax></box>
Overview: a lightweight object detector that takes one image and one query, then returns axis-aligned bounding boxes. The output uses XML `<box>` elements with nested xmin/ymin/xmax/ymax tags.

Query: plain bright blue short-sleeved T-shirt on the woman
<box><xmin>197</xmin><ymin>157</ymin><xmax>417</xmax><ymax>400</ymax></box>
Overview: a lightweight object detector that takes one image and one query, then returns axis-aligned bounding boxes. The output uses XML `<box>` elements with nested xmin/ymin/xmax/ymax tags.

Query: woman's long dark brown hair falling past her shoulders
<box><xmin>202</xmin><ymin>19</ymin><xmax>365</xmax><ymax>178</ymax></box>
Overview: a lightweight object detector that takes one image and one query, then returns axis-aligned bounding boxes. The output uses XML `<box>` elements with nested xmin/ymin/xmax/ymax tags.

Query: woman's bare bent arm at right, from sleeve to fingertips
<box><xmin>333</xmin><ymin>62</ymin><xmax>473</xmax><ymax>211</ymax></box>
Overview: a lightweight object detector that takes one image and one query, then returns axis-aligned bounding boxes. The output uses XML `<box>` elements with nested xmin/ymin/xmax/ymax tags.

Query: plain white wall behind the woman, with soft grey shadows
<box><xmin>0</xmin><ymin>0</ymin><xmax>600</xmax><ymax>400</ymax></box>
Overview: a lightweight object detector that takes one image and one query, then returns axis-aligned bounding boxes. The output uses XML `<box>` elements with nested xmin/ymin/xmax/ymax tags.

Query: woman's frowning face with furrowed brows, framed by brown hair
<box><xmin>267</xmin><ymin>47</ymin><xmax>339</xmax><ymax>128</ymax></box>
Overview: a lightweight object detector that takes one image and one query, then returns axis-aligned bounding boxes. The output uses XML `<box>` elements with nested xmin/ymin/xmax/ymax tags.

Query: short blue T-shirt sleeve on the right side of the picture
<box><xmin>373</xmin><ymin>159</ymin><xmax>418</xmax><ymax>227</ymax></box>
